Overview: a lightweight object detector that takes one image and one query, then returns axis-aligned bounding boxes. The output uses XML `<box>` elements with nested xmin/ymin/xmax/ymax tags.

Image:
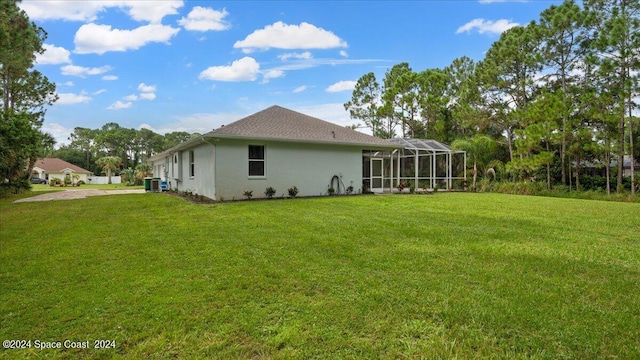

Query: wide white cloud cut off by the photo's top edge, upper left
<box><xmin>19</xmin><ymin>0</ymin><xmax>184</xmax><ymax>23</ymax></box>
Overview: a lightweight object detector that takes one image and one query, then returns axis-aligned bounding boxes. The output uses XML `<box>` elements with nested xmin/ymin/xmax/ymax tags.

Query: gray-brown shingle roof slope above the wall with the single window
<box><xmin>205</xmin><ymin>106</ymin><xmax>398</xmax><ymax>148</ymax></box>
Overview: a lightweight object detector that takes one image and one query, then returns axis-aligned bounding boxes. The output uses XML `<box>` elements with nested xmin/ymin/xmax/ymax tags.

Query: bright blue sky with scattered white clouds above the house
<box><xmin>19</xmin><ymin>0</ymin><xmax>561</xmax><ymax>145</ymax></box>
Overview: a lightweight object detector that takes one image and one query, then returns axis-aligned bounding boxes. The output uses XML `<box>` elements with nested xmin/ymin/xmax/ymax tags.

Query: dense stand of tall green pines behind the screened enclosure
<box><xmin>344</xmin><ymin>0</ymin><xmax>640</xmax><ymax>192</ymax></box>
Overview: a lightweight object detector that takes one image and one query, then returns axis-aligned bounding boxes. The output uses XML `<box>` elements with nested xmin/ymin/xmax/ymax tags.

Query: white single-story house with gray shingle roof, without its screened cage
<box><xmin>149</xmin><ymin>106</ymin><xmax>464</xmax><ymax>200</ymax></box>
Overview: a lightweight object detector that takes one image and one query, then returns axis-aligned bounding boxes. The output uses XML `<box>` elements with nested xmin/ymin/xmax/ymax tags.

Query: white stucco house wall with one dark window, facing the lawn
<box><xmin>215</xmin><ymin>139</ymin><xmax>362</xmax><ymax>200</ymax></box>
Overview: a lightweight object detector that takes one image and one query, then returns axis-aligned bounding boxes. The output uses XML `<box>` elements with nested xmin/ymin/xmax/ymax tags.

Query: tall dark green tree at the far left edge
<box><xmin>0</xmin><ymin>0</ymin><xmax>57</xmax><ymax>193</ymax></box>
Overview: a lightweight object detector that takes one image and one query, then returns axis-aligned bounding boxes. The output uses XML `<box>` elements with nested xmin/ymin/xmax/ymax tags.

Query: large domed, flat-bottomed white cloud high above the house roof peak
<box><xmin>233</xmin><ymin>21</ymin><xmax>347</xmax><ymax>53</ymax></box>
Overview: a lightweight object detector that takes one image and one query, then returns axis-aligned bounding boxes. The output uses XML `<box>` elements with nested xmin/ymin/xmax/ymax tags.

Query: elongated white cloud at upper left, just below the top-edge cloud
<box><xmin>74</xmin><ymin>24</ymin><xmax>180</xmax><ymax>55</ymax></box>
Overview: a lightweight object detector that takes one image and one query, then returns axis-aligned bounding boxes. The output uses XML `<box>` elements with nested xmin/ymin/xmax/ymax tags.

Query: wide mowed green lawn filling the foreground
<box><xmin>0</xmin><ymin>193</ymin><xmax>640</xmax><ymax>359</ymax></box>
